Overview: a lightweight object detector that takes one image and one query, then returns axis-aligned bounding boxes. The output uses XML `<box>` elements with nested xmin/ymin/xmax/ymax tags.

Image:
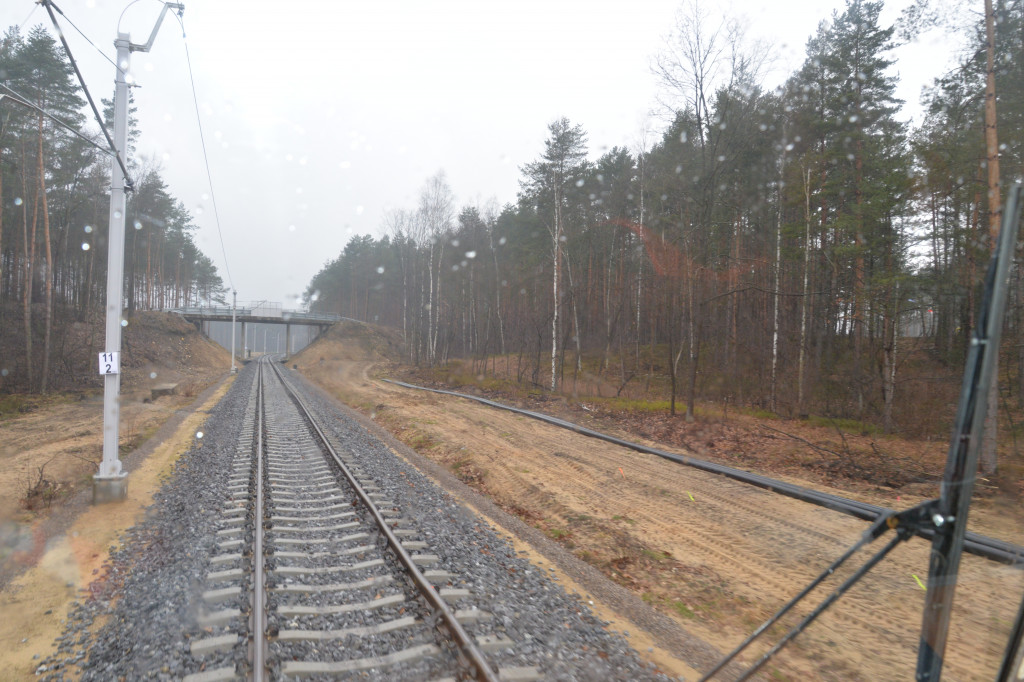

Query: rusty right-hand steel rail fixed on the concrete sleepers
<box><xmin>271</xmin><ymin>363</ymin><xmax>499</xmax><ymax>682</ymax></box>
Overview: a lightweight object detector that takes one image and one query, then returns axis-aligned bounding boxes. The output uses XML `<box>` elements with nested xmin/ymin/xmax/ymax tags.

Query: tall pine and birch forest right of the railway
<box><xmin>305</xmin><ymin>0</ymin><xmax>1024</xmax><ymax>430</ymax></box>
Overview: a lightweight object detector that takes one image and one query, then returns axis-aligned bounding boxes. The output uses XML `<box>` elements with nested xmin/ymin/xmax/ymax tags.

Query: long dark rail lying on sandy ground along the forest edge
<box><xmin>384</xmin><ymin>379</ymin><xmax>1024</xmax><ymax>568</ymax></box>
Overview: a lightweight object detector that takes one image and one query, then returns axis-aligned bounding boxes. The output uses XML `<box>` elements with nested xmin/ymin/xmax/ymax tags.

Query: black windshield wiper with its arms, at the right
<box><xmin>700</xmin><ymin>183</ymin><xmax>1024</xmax><ymax>682</ymax></box>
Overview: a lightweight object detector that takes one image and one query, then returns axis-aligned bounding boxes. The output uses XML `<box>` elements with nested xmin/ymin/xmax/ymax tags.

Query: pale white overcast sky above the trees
<box><xmin>0</xmin><ymin>0</ymin><xmax>954</xmax><ymax>307</ymax></box>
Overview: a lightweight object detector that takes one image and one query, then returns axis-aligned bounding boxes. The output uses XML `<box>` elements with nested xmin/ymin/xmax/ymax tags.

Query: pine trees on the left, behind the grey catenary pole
<box><xmin>0</xmin><ymin>27</ymin><xmax>225</xmax><ymax>392</ymax></box>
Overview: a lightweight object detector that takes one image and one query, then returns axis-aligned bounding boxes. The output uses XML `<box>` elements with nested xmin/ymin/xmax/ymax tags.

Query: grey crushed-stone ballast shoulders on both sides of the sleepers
<box><xmin>37</xmin><ymin>364</ymin><xmax>668</xmax><ymax>681</ymax></box>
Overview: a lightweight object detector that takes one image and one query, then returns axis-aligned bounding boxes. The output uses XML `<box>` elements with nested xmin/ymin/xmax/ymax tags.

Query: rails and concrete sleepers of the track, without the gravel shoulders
<box><xmin>184</xmin><ymin>361</ymin><xmax>540</xmax><ymax>682</ymax></box>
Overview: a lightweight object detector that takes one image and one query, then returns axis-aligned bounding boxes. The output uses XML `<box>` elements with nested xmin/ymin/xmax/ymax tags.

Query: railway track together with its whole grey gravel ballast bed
<box><xmin>39</xmin><ymin>361</ymin><xmax>668</xmax><ymax>682</ymax></box>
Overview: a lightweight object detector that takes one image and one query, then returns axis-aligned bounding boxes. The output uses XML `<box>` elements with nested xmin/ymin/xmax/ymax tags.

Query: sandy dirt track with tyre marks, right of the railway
<box><xmin>292</xmin><ymin>325</ymin><xmax>1024</xmax><ymax>682</ymax></box>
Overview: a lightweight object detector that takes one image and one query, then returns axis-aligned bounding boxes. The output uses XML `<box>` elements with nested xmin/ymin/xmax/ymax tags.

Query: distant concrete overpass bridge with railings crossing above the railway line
<box><xmin>164</xmin><ymin>301</ymin><xmax>342</xmax><ymax>356</ymax></box>
